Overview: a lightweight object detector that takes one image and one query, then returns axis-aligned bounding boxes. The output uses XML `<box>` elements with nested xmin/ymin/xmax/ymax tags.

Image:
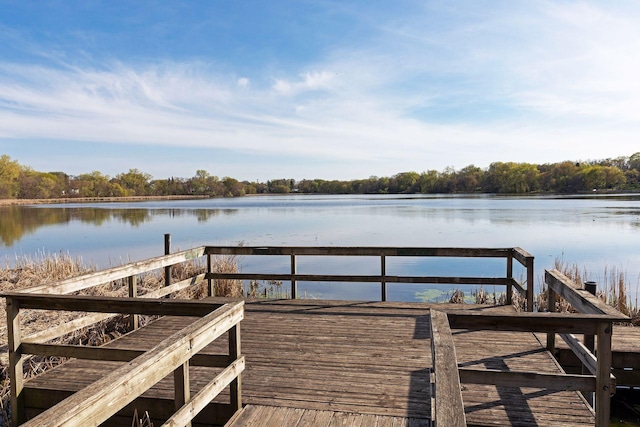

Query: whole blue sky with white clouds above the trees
<box><xmin>0</xmin><ymin>0</ymin><xmax>640</xmax><ymax>181</ymax></box>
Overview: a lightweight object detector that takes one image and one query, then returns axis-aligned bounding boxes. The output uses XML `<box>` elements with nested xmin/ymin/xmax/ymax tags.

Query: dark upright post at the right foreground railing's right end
<box><xmin>595</xmin><ymin>322</ymin><xmax>615</xmax><ymax>427</ymax></box>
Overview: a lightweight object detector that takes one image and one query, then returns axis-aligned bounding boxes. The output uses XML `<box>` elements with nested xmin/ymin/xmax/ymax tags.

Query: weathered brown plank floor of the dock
<box><xmin>24</xmin><ymin>300</ymin><xmax>595</xmax><ymax>427</ymax></box>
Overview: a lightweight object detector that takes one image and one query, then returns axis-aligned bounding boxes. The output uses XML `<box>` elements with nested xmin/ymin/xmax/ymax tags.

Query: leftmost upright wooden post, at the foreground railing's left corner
<box><xmin>7</xmin><ymin>297</ymin><xmax>26</xmax><ymax>426</ymax></box>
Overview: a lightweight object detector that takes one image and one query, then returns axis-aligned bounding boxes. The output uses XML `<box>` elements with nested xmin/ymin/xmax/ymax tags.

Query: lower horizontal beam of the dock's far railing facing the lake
<box><xmin>205</xmin><ymin>273</ymin><xmax>513</xmax><ymax>286</ymax></box>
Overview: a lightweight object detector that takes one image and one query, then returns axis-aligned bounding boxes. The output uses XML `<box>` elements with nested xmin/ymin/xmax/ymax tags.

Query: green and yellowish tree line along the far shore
<box><xmin>0</xmin><ymin>152</ymin><xmax>640</xmax><ymax>199</ymax></box>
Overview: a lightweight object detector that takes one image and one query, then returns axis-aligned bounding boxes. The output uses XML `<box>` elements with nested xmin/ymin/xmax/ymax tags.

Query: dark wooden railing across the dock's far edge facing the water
<box><xmin>205</xmin><ymin>246</ymin><xmax>534</xmax><ymax>311</ymax></box>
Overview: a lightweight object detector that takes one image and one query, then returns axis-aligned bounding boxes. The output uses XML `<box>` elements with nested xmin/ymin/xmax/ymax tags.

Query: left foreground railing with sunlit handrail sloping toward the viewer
<box><xmin>2</xmin><ymin>293</ymin><xmax>245</xmax><ymax>426</ymax></box>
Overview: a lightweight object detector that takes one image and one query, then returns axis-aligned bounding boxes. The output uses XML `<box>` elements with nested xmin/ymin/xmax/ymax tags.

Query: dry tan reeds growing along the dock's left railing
<box><xmin>0</xmin><ymin>254</ymin><xmax>242</xmax><ymax>427</ymax></box>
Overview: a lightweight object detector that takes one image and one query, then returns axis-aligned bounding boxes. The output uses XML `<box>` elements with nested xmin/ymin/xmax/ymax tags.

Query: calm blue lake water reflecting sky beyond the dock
<box><xmin>0</xmin><ymin>195</ymin><xmax>640</xmax><ymax>300</ymax></box>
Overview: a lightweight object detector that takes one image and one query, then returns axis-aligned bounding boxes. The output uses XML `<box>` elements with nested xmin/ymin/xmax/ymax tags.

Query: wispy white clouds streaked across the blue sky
<box><xmin>0</xmin><ymin>1</ymin><xmax>640</xmax><ymax>179</ymax></box>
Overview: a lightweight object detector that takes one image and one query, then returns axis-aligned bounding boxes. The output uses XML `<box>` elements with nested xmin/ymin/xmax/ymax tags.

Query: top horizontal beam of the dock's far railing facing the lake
<box><xmin>205</xmin><ymin>246</ymin><xmax>512</xmax><ymax>258</ymax></box>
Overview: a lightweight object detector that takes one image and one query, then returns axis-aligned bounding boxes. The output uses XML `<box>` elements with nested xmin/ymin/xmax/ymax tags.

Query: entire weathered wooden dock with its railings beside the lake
<box><xmin>2</xmin><ymin>246</ymin><xmax>628</xmax><ymax>427</ymax></box>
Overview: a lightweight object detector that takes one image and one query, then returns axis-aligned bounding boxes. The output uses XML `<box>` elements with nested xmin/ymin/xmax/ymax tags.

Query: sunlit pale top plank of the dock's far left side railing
<box><xmin>13</xmin><ymin>247</ymin><xmax>205</xmax><ymax>294</ymax></box>
